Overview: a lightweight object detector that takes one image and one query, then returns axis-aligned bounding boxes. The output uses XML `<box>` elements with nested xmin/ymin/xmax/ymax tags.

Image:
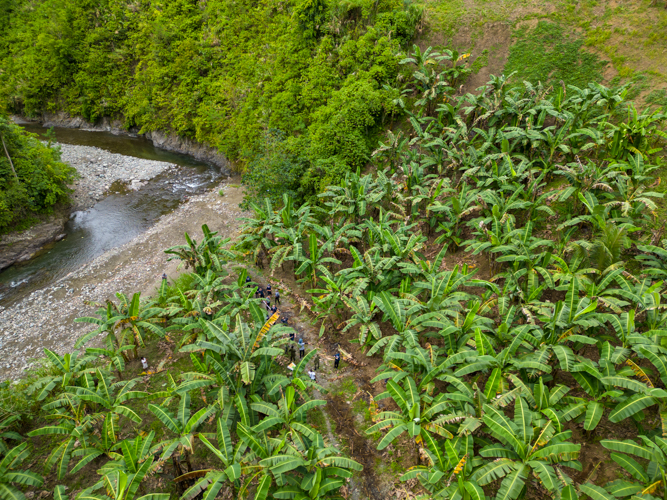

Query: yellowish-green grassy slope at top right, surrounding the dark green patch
<box><xmin>422</xmin><ymin>0</ymin><xmax>667</xmax><ymax>100</ymax></box>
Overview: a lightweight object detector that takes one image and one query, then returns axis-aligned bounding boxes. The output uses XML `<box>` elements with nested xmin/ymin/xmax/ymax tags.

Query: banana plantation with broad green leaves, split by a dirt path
<box><xmin>0</xmin><ymin>48</ymin><xmax>667</xmax><ymax>500</ymax></box>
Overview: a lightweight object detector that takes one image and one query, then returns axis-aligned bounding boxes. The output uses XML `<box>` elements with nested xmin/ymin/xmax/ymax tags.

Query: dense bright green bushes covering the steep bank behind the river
<box><xmin>0</xmin><ymin>0</ymin><xmax>421</xmax><ymax>204</ymax></box>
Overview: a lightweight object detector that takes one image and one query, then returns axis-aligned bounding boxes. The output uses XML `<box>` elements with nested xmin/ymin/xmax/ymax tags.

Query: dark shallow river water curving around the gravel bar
<box><xmin>0</xmin><ymin>125</ymin><xmax>225</xmax><ymax>306</ymax></box>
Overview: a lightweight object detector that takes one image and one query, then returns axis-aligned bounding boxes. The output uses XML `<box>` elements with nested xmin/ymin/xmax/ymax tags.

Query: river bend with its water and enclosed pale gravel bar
<box><xmin>0</xmin><ymin>125</ymin><xmax>227</xmax><ymax>307</ymax></box>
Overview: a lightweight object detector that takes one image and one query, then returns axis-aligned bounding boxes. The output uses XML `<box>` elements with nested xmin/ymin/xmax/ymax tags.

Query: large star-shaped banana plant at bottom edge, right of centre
<box><xmin>472</xmin><ymin>404</ymin><xmax>582</xmax><ymax>500</ymax></box>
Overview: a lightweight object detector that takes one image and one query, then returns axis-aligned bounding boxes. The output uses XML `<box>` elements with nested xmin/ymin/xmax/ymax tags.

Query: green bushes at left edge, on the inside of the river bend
<box><xmin>0</xmin><ymin>115</ymin><xmax>76</xmax><ymax>233</ymax></box>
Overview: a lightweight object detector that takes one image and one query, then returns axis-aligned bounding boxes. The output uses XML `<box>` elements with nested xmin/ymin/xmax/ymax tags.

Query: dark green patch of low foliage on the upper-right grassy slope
<box><xmin>505</xmin><ymin>21</ymin><xmax>604</xmax><ymax>87</ymax></box>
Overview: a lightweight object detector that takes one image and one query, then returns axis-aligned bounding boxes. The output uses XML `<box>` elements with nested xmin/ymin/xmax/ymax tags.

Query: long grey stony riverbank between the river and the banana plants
<box><xmin>0</xmin><ymin>184</ymin><xmax>248</xmax><ymax>379</ymax></box>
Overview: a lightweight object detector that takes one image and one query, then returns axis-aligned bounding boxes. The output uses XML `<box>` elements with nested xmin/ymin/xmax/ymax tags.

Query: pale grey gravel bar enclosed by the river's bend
<box><xmin>59</xmin><ymin>144</ymin><xmax>176</xmax><ymax>210</ymax></box>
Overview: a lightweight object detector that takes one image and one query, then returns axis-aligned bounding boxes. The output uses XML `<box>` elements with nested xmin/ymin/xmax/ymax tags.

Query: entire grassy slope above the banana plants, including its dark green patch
<box><xmin>422</xmin><ymin>0</ymin><xmax>667</xmax><ymax>100</ymax></box>
